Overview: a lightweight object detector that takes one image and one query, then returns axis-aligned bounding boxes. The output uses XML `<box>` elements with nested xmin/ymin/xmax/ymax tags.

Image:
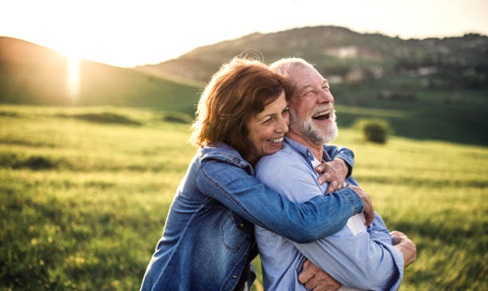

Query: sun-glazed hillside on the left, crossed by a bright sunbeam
<box><xmin>0</xmin><ymin>37</ymin><xmax>200</xmax><ymax>114</ymax></box>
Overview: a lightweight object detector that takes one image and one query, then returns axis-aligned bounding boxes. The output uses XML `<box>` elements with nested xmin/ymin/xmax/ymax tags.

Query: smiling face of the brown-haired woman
<box><xmin>246</xmin><ymin>92</ymin><xmax>290</xmax><ymax>164</ymax></box>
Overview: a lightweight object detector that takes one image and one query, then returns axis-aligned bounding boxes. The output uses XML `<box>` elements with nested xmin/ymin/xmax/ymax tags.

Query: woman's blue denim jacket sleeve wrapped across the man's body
<box><xmin>197</xmin><ymin>159</ymin><xmax>364</xmax><ymax>243</ymax></box>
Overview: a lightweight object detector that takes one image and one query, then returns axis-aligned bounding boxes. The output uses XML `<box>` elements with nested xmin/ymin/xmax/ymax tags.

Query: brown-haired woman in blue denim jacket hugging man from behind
<box><xmin>141</xmin><ymin>58</ymin><xmax>367</xmax><ymax>290</ymax></box>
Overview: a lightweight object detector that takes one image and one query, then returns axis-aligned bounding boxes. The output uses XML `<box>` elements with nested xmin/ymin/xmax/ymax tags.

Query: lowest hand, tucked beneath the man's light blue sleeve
<box><xmin>298</xmin><ymin>260</ymin><xmax>342</xmax><ymax>291</ymax></box>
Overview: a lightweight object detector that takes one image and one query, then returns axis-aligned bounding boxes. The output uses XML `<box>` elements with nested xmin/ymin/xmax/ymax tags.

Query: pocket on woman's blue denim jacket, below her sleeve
<box><xmin>220</xmin><ymin>212</ymin><xmax>249</xmax><ymax>253</ymax></box>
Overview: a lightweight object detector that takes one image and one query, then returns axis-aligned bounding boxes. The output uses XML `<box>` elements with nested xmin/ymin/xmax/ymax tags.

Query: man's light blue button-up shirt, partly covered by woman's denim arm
<box><xmin>255</xmin><ymin>138</ymin><xmax>404</xmax><ymax>290</ymax></box>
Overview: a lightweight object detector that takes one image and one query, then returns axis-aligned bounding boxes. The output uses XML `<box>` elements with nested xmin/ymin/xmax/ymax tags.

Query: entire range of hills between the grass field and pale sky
<box><xmin>0</xmin><ymin>26</ymin><xmax>488</xmax><ymax>146</ymax></box>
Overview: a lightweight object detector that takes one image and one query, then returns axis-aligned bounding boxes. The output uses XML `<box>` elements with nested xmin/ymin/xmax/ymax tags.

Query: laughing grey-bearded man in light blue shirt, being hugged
<box><xmin>255</xmin><ymin>58</ymin><xmax>416</xmax><ymax>290</ymax></box>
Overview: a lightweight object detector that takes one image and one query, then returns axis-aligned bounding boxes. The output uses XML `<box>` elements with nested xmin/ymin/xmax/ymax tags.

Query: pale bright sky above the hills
<box><xmin>0</xmin><ymin>0</ymin><xmax>488</xmax><ymax>67</ymax></box>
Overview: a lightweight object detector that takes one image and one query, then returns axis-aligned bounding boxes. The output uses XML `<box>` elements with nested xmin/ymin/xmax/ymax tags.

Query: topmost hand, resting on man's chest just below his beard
<box><xmin>315</xmin><ymin>159</ymin><xmax>348</xmax><ymax>194</ymax></box>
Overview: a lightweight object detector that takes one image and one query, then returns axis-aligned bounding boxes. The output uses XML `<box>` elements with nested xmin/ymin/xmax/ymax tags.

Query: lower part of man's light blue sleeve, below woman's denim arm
<box><xmin>294</xmin><ymin>218</ymin><xmax>404</xmax><ymax>290</ymax></box>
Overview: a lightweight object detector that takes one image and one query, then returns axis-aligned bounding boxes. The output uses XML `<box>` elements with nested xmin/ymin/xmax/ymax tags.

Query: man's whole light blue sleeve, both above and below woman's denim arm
<box><xmin>257</xmin><ymin>148</ymin><xmax>403</xmax><ymax>290</ymax></box>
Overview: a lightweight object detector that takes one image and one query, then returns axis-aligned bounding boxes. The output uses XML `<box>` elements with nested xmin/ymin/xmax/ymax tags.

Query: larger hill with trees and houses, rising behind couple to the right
<box><xmin>136</xmin><ymin>26</ymin><xmax>488</xmax><ymax>145</ymax></box>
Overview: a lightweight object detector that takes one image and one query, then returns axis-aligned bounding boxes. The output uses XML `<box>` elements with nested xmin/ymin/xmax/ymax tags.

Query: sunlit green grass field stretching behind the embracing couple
<box><xmin>0</xmin><ymin>106</ymin><xmax>488</xmax><ymax>290</ymax></box>
